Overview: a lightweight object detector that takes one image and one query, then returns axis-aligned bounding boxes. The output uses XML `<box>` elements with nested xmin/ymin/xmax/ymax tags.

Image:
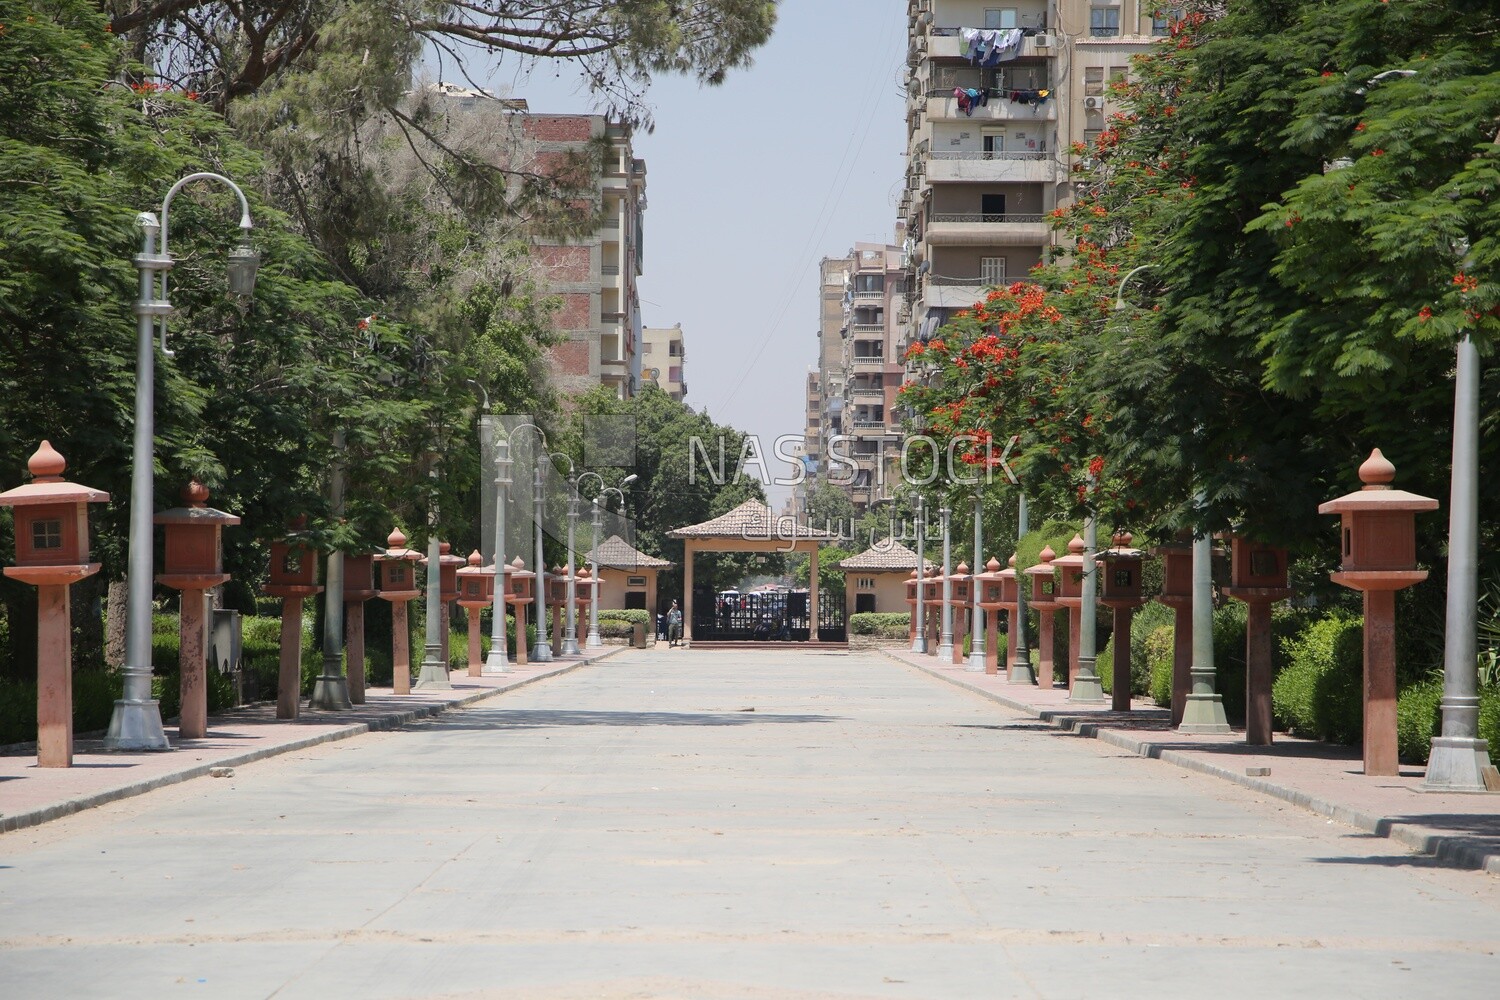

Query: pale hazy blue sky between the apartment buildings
<box><xmin>450</xmin><ymin>0</ymin><xmax>906</xmax><ymax>507</ymax></box>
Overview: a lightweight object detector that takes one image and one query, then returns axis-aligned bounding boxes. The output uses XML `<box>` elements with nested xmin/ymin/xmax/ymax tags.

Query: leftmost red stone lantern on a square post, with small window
<box><xmin>0</xmin><ymin>441</ymin><xmax>110</xmax><ymax>768</ymax></box>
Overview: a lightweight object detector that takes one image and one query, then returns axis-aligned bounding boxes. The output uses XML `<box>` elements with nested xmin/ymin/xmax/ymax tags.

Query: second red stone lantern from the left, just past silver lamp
<box><xmin>153</xmin><ymin>480</ymin><xmax>240</xmax><ymax>739</ymax></box>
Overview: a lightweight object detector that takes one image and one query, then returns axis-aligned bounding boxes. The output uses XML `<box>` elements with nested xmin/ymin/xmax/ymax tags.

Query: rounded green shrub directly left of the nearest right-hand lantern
<box><xmin>1271</xmin><ymin>612</ymin><xmax>1364</xmax><ymax>744</ymax></box>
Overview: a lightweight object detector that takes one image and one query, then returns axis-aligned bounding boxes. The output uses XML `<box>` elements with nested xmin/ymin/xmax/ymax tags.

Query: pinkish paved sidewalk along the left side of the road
<box><xmin>0</xmin><ymin>646</ymin><xmax>626</xmax><ymax>834</ymax></box>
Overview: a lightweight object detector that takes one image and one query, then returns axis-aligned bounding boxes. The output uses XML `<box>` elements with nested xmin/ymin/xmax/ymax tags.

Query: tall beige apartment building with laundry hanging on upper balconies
<box><xmin>899</xmin><ymin>0</ymin><xmax>1169</xmax><ymax>353</ymax></box>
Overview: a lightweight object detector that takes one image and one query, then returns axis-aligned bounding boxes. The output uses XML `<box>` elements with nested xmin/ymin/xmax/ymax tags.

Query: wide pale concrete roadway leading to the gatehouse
<box><xmin>0</xmin><ymin>649</ymin><xmax>1500</xmax><ymax>1000</ymax></box>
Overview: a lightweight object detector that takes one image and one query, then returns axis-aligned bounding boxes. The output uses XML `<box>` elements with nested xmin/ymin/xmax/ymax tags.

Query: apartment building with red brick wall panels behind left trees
<box><xmin>425</xmin><ymin>82</ymin><xmax>647</xmax><ymax>399</ymax></box>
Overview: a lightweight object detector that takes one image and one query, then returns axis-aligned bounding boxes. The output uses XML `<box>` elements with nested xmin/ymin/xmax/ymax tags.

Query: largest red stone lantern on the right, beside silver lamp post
<box><xmin>1317</xmin><ymin>448</ymin><xmax>1437</xmax><ymax>775</ymax></box>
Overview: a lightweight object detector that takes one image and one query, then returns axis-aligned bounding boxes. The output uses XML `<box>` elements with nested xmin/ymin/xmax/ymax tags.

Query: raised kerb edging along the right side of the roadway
<box><xmin>879</xmin><ymin>649</ymin><xmax>1500</xmax><ymax>874</ymax></box>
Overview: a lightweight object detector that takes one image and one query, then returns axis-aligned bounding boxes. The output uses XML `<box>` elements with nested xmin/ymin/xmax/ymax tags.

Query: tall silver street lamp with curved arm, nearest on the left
<box><xmin>105</xmin><ymin>172</ymin><xmax>260</xmax><ymax>750</ymax></box>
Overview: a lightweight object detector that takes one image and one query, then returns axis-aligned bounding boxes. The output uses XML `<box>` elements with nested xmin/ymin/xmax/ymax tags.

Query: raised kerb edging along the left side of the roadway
<box><xmin>0</xmin><ymin>646</ymin><xmax>624</xmax><ymax>834</ymax></box>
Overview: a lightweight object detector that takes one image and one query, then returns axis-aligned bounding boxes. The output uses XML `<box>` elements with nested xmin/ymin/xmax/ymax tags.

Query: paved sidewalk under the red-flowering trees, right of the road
<box><xmin>881</xmin><ymin>649</ymin><xmax>1500</xmax><ymax>874</ymax></box>
